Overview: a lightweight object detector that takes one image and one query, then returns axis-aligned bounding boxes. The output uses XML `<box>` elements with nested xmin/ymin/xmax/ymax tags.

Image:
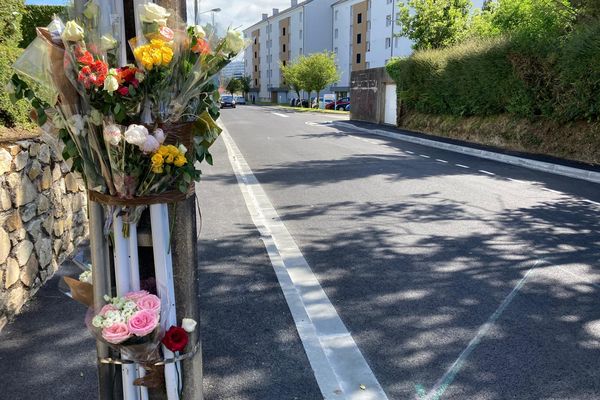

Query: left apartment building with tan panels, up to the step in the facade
<box><xmin>244</xmin><ymin>0</ymin><xmax>335</xmax><ymax>103</ymax></box>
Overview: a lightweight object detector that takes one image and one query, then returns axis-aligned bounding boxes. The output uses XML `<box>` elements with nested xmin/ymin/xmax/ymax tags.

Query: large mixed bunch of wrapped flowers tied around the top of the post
<box><xmin>11</xmin><ymin>0</ymin><xmax>245</xmax><ymax>234</ymax></box>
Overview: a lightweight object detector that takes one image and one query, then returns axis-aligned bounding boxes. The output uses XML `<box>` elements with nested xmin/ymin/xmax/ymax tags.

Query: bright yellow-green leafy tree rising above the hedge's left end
<box><xmin>397</xmin><ymin>0</ymin><xmax>473</xmax><ymax>50</ymax></box>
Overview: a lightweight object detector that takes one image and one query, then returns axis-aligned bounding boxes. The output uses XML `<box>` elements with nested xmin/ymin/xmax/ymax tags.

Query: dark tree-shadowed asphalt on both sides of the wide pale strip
<box><xmin>201</xmin><ymin>106</ymin><xmax>600</xmax><ymax>400</ymax></box>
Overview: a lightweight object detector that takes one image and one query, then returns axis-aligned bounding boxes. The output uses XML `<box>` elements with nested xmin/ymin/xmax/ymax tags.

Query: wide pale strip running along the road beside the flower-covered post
<box><xmin>220</xmin><ymin>124</ymin><xmax>387</xmax><ymax>400</ymax></box>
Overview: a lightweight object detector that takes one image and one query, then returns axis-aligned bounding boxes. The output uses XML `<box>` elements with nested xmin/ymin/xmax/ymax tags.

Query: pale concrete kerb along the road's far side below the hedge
<box><xmin>334</xmin><ymin>121</ymin><xmax>600</xmax><ymax>183</ymax></box>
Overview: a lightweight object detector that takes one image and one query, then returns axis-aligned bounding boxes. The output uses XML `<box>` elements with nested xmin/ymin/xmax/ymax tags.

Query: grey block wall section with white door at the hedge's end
<box><xmin>350</xmin><ymin>68</ymin><xmax>395</xmax><ymax>124</ymax></box>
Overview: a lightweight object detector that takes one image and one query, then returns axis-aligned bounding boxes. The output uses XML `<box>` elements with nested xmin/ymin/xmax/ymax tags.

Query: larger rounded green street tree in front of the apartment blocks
<box><xmin>296</xmin><ymin>51</ymin><xmax>340</xmax><ymax>108</ymax></box>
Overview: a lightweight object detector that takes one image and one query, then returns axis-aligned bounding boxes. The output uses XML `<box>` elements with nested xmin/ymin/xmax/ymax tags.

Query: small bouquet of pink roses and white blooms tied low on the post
<box><xmin>91</xmin><ymin>290</ymin><xmax>161</xmax><ymax>346</ymax></box>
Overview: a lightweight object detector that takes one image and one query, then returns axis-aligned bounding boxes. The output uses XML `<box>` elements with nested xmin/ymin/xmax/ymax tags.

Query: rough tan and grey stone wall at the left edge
<box><xmin>0</xmin><ymin>137</ymin><xmax>88</xmax><ymax>329</ymax></box>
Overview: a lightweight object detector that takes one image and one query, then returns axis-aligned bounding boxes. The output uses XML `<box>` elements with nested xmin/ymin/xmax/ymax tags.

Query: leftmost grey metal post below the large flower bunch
<box><xmin>88</xmin><ymin>201</ymin><xmax>114</xmax><ymax>400</ymax></box>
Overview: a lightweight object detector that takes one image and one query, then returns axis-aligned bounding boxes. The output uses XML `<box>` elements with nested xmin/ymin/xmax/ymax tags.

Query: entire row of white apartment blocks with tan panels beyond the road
<box><xmin>244</xmin><ymin>0</ymin><xmax>484</xmax><ymax>103</ymax></box>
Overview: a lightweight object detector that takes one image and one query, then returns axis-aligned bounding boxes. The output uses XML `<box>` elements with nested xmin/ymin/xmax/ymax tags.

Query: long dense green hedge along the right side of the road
<box><xmin>387</xmin><ymin>23</ymin><xmax>600</xmax><ymax>122</ymax></box>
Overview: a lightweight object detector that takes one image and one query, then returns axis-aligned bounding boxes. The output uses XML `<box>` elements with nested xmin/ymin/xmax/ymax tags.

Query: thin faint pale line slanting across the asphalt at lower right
<box><xmin>422</xmin><ymin>261</ymin><xmax>540</xmax><ymax>400</ymax></box>
